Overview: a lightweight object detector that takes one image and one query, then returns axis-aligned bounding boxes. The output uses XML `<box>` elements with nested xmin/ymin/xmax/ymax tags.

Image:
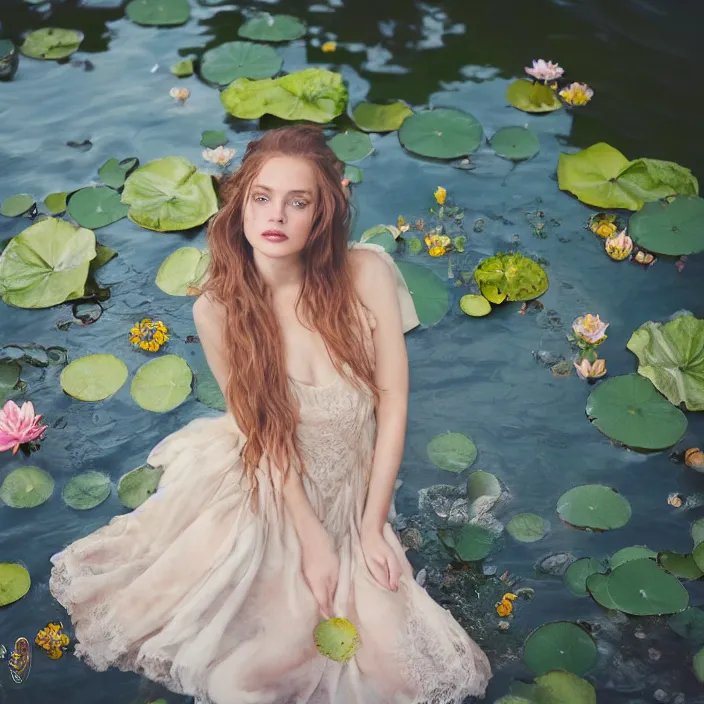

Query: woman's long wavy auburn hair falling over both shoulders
<box><xmin>203</xmin><ymin>125</ymin><xmax>379</xmax><ymax>501</ymax></box>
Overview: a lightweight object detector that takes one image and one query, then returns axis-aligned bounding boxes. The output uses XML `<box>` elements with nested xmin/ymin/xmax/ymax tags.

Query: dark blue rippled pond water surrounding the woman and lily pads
<box><xmin>0</xmin><ymin>0</ymin><xmax>704</xmax><ymax>704</ymax></box>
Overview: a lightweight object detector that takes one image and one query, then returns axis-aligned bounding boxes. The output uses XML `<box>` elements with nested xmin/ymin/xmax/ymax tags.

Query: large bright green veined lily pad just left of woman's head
<box><xmin>122</xmin><ymin>156</ymin><xmax>218</xmax><ymax>232</ymax></box>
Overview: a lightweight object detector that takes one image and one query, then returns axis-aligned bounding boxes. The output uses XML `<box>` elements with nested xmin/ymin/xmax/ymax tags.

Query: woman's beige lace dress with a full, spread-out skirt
<box><xmin>50</xmin><ymin>244</ymin><xmax>491</xmax><ymax>704</ymax></box>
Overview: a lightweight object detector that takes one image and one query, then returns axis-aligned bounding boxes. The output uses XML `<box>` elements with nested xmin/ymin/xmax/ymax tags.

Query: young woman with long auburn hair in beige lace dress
<box><xmin>50</xmin><ymin>126</ymin><xmax>491</xmax><ymax>704</ymax></box>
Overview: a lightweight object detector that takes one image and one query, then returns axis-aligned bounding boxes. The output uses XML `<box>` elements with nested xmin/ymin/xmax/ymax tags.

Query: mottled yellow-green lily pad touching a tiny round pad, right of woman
<box><xmin>474</xmin><ymin>252</ymin><xmax>549</xmax><ymax>304</ymax></box>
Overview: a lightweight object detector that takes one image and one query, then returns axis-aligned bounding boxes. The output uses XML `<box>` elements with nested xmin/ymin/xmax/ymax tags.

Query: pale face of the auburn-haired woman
<box><xmin>244</xmin><ymin>156</ymin><xmax>318</xmax><ymax>259</ymax></box>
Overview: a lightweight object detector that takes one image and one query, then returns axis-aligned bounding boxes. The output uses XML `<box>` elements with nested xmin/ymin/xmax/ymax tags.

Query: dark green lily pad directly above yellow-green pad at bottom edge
<box><xmin>523</xmin><ymin>621</ymin><xmax>597</xmax><ymax>675</ymax></box>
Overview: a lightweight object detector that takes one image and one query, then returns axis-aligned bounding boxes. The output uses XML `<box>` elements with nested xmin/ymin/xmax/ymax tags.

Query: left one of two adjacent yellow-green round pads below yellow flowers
<box><xmin>61</xmin><ymin>354</ymin><xmax>127</xmax><ymax>401</ymax></box>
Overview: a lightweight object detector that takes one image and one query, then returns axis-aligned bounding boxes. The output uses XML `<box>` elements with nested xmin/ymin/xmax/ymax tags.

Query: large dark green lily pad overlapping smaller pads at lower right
<box><xmin>608</xmin><ymin>558</ymin><xmax>689</xmax><ymax>616</ymax></box>
